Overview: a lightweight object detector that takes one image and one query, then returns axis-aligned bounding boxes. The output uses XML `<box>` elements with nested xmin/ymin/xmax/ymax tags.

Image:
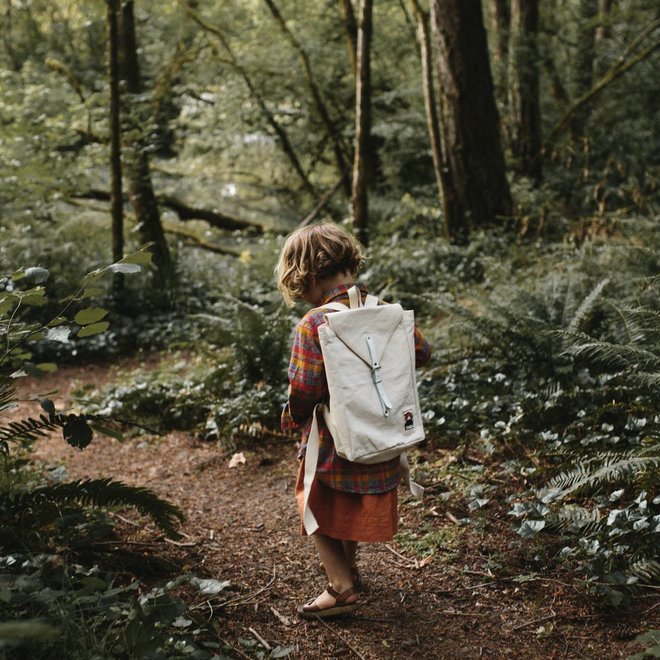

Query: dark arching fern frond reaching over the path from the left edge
<box><xmin>0</xmin><ymin>479</ymin><xmax>184</xmax><ymax>538</ymax></box>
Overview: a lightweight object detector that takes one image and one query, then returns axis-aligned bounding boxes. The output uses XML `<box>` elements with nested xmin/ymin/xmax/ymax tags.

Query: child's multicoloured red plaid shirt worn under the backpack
<box><xmin>282</xmin><ymin>284</ymin><xmax>431</xmax><ymax>494</ymax></box>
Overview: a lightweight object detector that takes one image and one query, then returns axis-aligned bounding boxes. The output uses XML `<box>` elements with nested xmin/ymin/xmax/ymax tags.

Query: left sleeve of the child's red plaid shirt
<box><xmin>281</xmin><ymin>314</ymin><xmax>328</xmax><ymax>431</ymax></box>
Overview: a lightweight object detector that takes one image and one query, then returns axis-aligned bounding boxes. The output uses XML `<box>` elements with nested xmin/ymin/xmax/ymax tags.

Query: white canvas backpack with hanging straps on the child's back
<box><xmin>303</xmin><ymin>286</ymin><xmax>424</xmax><ymax>534</ymax></box>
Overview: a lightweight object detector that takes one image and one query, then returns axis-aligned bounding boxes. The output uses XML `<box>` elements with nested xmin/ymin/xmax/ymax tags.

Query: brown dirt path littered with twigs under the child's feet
<box><xmin>21</xmin><ymin>358</ymin><xmax>660</xmax><ymax>659</ymax></box>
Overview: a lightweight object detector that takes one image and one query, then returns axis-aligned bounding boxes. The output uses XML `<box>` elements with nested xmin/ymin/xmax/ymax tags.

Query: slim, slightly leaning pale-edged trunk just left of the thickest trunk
<box><xmin>411</xmin><ymin>0</ymin><xmax>449</xmax><ymax>224</ymax></box>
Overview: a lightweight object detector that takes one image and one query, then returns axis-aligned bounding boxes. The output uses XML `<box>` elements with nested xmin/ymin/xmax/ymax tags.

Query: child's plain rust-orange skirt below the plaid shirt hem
<box><xmin>296</xmin><ymin>460</ymin><xmax>399</xmax><ymax>543</ymax></box>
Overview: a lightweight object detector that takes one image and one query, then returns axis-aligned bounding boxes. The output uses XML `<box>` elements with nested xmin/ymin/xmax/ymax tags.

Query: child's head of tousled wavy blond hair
<box><xmin>275</xmin><ymin>222</ymin><xmax>364</xmax><ymax>306</ymax></box>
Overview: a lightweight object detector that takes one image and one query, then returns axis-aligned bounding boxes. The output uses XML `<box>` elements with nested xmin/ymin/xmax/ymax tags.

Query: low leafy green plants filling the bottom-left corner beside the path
<box><xmin>0</xmin><ymin>553</ymin><xmax>231</xmax><ymax>660</ymax></box>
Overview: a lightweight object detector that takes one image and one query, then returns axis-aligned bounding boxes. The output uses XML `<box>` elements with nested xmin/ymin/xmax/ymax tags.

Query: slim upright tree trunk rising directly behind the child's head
<box><xmin>351</xmin><ymin>0</ymin><xmax>373</xmax><ymax>245</ymax></box>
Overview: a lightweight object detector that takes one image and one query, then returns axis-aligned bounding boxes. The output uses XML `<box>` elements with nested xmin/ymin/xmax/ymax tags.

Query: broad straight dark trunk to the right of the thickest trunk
<box><xmin>509</xmin><ymin>0</ymin><xmax>541</xmax><ymax>182</ymax></box>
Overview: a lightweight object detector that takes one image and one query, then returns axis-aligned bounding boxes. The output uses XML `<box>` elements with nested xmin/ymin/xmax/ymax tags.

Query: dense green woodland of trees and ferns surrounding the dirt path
<box><xmin>0</xmin><ymin>0</ymin><xmax>660</xmax><ymax>657</ymax></box>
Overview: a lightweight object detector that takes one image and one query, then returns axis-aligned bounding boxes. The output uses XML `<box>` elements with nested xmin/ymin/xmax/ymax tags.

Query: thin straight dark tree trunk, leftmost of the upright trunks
<box><xmin>107</xmin><ymin>0</ymin><xmax>124</xmax><ymax>302</ymax></box>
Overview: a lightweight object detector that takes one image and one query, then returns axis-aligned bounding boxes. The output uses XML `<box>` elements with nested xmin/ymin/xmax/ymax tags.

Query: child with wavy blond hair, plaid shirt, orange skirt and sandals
<box><xmin>276</xmin><ymin>223</ymin><xmax>431</xmax><ymax>618</ymax></box>
